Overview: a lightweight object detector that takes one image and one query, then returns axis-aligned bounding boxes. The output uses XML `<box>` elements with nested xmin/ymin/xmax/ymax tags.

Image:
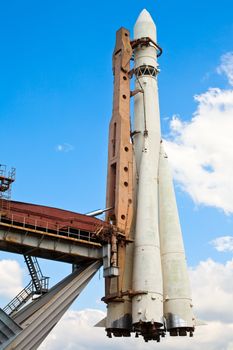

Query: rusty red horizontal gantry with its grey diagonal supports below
<box><xmin>0</xmin><ymin>200</ymin><xmax>111</xmax><ymax>350</ymax></box>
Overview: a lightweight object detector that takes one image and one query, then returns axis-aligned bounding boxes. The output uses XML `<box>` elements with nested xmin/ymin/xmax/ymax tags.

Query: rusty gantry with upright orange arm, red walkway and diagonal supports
<box><xmin>0</xmin><ymin>28</ymin><xmax>138</xmax><ymax>350</ymax></box>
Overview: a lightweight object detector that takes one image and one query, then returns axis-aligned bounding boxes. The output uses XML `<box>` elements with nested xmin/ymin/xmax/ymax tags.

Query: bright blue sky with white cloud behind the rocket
<box><xmin>0</xmin><ymin>0</ymin><xmax>233</xmax><ymax>350</ymax></box>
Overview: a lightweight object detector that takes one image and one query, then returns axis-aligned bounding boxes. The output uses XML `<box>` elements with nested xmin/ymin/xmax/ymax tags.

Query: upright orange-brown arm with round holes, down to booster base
<box><xmin>103</xmin><ymin>28</ymin><xmax>135</xmax><ymax>336</ymax></box>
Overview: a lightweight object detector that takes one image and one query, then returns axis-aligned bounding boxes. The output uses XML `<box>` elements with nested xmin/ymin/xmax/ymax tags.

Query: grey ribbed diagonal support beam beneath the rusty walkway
<box><xmin>3</xmin><ymin>261</ymin><xmax>102</xmax><ymax>350</ymax></box>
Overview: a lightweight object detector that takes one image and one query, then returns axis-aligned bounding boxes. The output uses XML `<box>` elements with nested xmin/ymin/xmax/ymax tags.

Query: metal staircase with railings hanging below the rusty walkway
<box><xmin>3</xmin><ymin>255</ymin><xmax>49</xmax><ymax>316</ymax></box>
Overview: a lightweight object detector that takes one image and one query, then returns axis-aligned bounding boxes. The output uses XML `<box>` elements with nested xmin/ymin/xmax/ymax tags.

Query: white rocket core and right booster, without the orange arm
<box><xmin>132</xmin><ymin>10</ymin><xmax>194</xmax><ymax>339</ymax></box>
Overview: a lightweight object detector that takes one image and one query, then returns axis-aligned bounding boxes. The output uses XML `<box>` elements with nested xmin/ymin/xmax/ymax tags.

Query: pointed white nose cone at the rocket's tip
<box><xmin>134</xmin><ymin>9</ymin><xmax>156</xmax><ymax>42</ymax></box>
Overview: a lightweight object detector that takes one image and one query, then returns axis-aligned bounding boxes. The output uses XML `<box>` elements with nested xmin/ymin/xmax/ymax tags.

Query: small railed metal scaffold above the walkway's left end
<box><xmin>0</xmin><ymin>164</ymin><xmax>16</xmax><ymax>215</ymax></box>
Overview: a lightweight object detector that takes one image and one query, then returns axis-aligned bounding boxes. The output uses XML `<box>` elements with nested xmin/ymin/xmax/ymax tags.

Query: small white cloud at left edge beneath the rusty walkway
<box><xmin>0</xmin><ymin>260</ymin><xmax>23</xmax><ymax>299</ymax></box>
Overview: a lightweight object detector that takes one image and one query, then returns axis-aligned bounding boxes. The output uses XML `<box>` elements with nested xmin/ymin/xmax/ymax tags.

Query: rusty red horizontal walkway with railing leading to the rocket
<box><xmin>0</xmin><ymin>201</ymin><xmax>111</xmax><ymax>264</ymax></box>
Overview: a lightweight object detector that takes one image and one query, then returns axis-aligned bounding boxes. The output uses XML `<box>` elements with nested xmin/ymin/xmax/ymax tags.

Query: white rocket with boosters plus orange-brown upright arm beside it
<box><xmin>101</xmin><ymin>10</ymin><xmax>195</xmax><ymax>341</ymax></box>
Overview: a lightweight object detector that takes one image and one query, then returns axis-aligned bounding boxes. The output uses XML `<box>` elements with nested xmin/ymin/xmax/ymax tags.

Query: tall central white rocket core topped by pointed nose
<box><xmin>132</xmin><ymin>10</ymin><xmax>163</xmax><ymax>330</ymax></box>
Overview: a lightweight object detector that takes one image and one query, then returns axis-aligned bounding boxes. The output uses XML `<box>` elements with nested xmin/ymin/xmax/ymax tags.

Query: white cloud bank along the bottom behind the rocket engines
<box><xmin>39</xmin><ymin>310</ymin><xmax>233</xmax><ymax>350</ymax></box>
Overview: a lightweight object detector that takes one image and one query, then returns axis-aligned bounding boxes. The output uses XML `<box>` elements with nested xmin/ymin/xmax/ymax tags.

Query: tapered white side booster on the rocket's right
<box><xmin>159</xmin><ymin>144</ymin><xmax>194</xmax><ymax>335</ymax></box>
